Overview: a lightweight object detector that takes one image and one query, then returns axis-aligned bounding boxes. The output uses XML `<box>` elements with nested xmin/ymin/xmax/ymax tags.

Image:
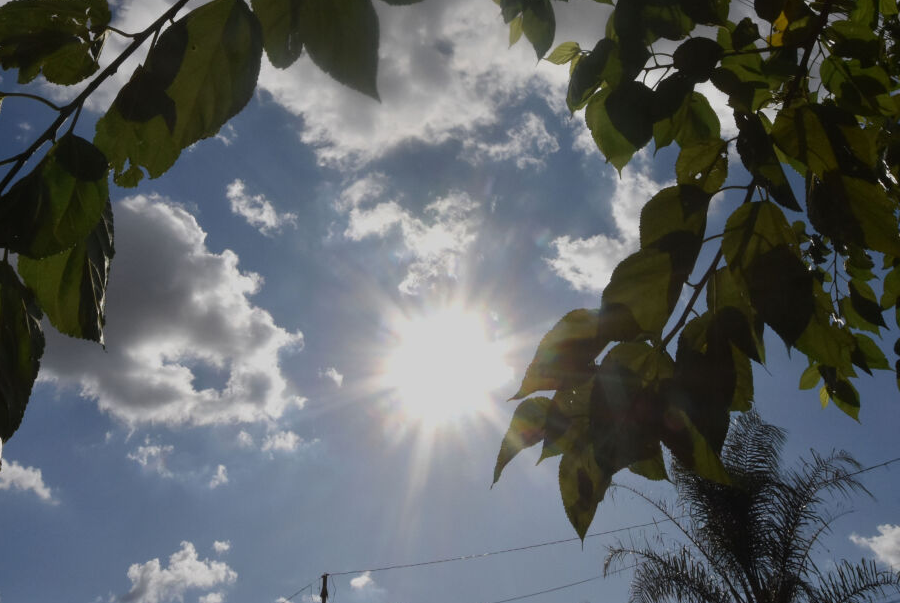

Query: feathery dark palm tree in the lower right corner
<box><xmin>604</xmin><ymin>413</ymin><xmax>900</xmax><ymax>603</ymax></box>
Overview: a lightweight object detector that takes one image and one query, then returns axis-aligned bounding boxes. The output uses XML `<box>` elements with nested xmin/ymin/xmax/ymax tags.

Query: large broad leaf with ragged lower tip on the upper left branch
<box><xmin>94</xmin><ymin>0</ymin><xmax>262</xmax><ymax>186</ymax></box>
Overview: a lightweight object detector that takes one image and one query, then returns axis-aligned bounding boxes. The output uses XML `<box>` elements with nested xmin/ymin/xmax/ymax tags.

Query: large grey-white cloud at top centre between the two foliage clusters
<box><xmin>253</xmin><ymin>0</ymin><xmax>568</xmax><ymax>165</ymax></box>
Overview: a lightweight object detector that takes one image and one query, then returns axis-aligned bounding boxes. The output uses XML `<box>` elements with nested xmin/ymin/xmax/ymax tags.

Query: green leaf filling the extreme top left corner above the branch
<box><xmin>0</xmin><ymin>0</ymin><xmax>110</xmax><ymax>85</ymax></box>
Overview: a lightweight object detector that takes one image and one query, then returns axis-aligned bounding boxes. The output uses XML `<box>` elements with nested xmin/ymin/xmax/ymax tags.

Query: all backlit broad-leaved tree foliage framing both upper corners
<box><xmin>0</xmin><ymin>0</ymin><xmax>900</xmax><ymax>536</ymax></box>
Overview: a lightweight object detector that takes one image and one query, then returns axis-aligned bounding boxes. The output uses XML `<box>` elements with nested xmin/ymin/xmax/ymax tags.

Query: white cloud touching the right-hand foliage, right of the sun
<box><xmin>547</xmin><ymin>162</ymin><xmax>669</xmax><ymax>293</ymax></box>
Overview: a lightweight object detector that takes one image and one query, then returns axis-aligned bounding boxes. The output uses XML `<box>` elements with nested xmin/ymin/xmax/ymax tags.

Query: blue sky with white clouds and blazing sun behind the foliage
<box><xmin>0</xmin><ymin>0</ymin><xmax>900</xmax><ymax>603</ymax></box>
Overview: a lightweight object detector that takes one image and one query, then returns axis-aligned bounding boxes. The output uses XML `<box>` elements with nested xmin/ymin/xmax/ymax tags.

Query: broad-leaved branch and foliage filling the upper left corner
<box><xmin>0</xmin><ymin>0</ymin><xmax>419</xmax><ymax>452</ymax></box>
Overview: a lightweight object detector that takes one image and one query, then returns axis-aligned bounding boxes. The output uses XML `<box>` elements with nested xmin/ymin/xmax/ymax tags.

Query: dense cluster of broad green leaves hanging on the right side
<box><xmin>494</xmin><ymin>0</ymin><xmax>900</xmax><ymax>537</ymax></box>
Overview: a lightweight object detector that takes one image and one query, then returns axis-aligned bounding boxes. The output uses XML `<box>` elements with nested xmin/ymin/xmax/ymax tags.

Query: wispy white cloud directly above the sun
<box><xmin>339</xmin><ymin>186</ymin><xmax>481</xmax><ymax>295</ymax></box>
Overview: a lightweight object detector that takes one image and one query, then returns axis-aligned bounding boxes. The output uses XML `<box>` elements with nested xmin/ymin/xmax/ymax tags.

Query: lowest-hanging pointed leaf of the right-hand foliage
<box><xmin>559</xmin><ymin>446</ymin><xmax>612</xmax><ymax>540</ymax></box>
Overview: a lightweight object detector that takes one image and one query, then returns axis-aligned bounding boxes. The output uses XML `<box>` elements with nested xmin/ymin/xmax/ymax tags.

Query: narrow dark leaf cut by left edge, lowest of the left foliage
<box><xmin>0</xmin><ymin>262</ymin><xmax>44</xmax><ymax>442</ymax></box>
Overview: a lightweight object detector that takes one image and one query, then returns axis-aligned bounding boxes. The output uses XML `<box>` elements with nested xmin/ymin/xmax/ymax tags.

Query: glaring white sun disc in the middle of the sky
<box><xmin>382</xmin><ymin>306</ymin><xmax>513</xmax><ymax>427</ymax></box>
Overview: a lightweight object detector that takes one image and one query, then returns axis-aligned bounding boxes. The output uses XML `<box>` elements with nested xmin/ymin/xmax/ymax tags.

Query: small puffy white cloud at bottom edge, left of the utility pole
<box><xmin>120</xmin><ymin>541</ymin><xmax>237</xmax><ymax>603</ymax></box>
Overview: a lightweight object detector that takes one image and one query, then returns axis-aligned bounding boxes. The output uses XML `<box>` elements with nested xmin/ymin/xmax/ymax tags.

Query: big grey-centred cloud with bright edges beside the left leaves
<box><xmin>40</xmin><ymin>195</ymin><xmax>303</xmax><ymax>426</ymax></box>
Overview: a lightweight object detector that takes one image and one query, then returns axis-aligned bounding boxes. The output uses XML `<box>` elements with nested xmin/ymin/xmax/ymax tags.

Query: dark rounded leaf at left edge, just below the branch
<box><xmin>0</xmin><ymin>134</ymin><xmax>109</xmax><ymax>258</ymax></box>
